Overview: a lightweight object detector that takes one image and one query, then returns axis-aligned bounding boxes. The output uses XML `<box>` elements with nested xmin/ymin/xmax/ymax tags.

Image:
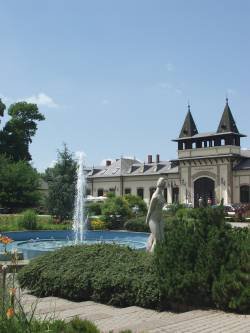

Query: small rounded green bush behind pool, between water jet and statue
<box><xmin>102</xmin><ymin>195</ymin><xmax>132</xmax><ymax>229</ymax></box>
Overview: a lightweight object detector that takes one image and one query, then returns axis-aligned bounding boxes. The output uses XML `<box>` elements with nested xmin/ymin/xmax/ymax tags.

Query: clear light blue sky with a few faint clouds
<box><xmin>0</xmin><ymin>0</ymin><xmax>250</xmax><ymax>171</ymax></box>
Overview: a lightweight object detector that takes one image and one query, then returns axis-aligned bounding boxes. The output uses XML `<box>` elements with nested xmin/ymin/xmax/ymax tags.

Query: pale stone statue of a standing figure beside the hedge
<box><xmin>146</xmin><ymin>177</ymin><xmax>166</xmax><ymax>252</ymax></box>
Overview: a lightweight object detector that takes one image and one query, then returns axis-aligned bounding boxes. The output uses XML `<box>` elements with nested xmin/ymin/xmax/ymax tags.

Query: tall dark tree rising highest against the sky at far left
<box><xmin>0</xmin><ymin>102</ymin><xmax>45</xmax><ymax>161</ymax></box>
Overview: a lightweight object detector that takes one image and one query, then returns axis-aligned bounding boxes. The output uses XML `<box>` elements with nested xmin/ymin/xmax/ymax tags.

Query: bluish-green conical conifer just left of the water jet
<box><xmin>44</xmin><ymin>144</ymin><xmax>76</xmax><ymax>222</ymax></box>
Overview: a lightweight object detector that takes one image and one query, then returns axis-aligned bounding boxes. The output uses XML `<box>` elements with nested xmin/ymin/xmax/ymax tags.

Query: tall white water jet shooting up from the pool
<box><xmin>73</xmin><ymin>153</ymin><xmax>87</xmax><ymax>244</ymax></box>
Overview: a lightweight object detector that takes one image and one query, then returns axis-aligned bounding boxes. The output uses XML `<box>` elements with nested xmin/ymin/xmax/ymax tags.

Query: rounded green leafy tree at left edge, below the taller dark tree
<box><xmin>0</xmin><ymin>155</ymin><xmax>40</xmax><ymax>209</ymax></box>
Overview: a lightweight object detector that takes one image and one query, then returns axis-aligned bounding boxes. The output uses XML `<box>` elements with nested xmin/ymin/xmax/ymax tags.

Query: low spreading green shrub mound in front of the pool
<box><xmin>18</xmin><ymin>244</ymin><xmax>159</xmax><ymax>308</ymax></box>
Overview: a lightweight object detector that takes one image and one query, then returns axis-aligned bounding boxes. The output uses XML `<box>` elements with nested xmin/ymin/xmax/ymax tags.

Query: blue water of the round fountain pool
<box><xmin>0</xmin><ymin>230</ymin><xmax>149</xmax><ymax>259</ymax></box>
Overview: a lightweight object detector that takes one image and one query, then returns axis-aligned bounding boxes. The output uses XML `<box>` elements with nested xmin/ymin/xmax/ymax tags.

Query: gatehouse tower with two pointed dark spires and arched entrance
<box><xmin>173</xmin><ymin>98</ymin><xmax>245</xmax><ymax>206</ymax></box>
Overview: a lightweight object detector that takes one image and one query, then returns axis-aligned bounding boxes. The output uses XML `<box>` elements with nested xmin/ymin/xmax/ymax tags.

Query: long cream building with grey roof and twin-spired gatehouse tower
<box><xmin>87</xmin><ymin>99</ymin><xmax>250</xmax><ymax>206</ymax></box>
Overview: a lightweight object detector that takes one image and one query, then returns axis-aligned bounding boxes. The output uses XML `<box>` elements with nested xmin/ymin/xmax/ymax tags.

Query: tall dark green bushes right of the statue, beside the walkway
<box><xmin>155</xmin><ymin>208</ymin><xmax>250</xmax><ymax>312</ymax></box>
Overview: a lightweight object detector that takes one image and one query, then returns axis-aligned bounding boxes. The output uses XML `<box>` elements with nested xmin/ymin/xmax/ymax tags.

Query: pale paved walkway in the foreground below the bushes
<box><xmin>22</xmin><ymin>294</ymin><xmax>250</xmax><ymax>333</ymax></box>
